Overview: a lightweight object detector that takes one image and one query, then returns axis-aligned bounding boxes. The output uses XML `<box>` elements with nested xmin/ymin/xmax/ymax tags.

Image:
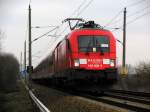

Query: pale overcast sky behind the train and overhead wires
<box><xmin>0</xmin><ymin>0</ymin><xmax>150</xmax><ymax>65</ymax></box>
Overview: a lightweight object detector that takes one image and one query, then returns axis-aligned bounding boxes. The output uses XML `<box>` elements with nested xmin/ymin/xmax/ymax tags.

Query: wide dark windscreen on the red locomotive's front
<box><xmin>78</xmin><ymin>35</ymin><xmax>109</xmax><ymax>52</ymax></box>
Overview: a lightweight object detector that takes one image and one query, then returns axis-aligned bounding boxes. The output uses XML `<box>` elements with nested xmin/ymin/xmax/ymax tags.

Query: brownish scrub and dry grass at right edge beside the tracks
<box><xmin>114</xmin><ymin>62</ymin><xmax>150</xmax><ymax>92</ymax></box>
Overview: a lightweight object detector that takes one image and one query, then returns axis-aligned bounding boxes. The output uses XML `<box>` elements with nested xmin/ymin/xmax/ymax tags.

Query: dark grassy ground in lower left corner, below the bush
<box><xmin>0</xmin><ymin>81</ymin><xmax>33</xmax><ymax>112</ymax></box>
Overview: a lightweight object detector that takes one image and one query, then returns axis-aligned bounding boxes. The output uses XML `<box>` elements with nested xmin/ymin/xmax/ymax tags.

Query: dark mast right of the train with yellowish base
<box><xmin>122</xmin><ymin>8</ymin><xmax>127</xmax><ymax>75</ymax></box>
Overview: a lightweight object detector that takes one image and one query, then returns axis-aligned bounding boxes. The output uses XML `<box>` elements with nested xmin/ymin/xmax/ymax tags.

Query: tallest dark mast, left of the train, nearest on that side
<box><xmin>28</xmin><ymin>4</ymin><xmax>32</xmax><ymax>88</ymax></box>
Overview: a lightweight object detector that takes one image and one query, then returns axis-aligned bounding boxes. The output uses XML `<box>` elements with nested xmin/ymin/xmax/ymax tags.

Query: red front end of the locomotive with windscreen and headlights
<box><xmin>70</xmin><ymin>28</ymin><xmax>118</xmax><ymax>81</ymax></box>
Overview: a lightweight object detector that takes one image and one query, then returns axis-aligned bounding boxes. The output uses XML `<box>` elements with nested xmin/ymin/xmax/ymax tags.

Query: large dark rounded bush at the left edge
<box><xmin>0</xmin><ymin>54</ymin><xmax>19</xmax><ymax>91</ymax></box>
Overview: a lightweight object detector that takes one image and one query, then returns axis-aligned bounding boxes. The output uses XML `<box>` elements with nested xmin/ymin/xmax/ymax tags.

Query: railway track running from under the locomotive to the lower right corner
<box><xmin>31</xmin><ymin>80</ymin><xmax>150</xmax><ymax>112</ymax></box>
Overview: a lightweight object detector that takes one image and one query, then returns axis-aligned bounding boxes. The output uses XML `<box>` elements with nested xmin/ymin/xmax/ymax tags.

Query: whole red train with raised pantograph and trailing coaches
<box><xmin>31</xmin><ymin>19</ymin><xmax>118</xmax><ymax>84</ymax></box>
